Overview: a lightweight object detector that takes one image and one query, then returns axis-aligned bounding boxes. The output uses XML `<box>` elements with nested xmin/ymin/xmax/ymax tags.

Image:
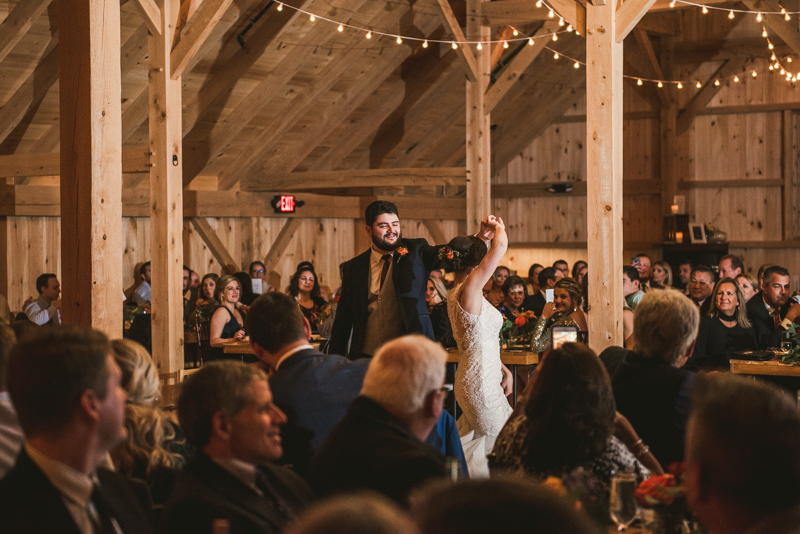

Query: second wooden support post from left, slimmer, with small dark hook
<box><xmin>149</xmin><ymin>0</ymin><xmax>183</xmax><ymax>373</ymax></box>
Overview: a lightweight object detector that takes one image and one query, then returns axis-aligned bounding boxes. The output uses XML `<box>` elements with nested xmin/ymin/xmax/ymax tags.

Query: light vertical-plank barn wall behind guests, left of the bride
<box><xmin>0</xmin><ymin>217</ymin><xmax>458</xmax><ymax>311</ymax></box>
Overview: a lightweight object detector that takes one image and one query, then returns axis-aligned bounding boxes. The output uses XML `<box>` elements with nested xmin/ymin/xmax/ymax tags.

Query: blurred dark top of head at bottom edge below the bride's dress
<box><xmin>413</xmin><ymin>478</ymin><xmax>596</xmax><ymax>534</ymax></box>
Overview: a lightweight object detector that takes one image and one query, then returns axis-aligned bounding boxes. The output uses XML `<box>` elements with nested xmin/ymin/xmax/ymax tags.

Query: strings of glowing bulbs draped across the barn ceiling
<box><xmin>276</xmin><ymin>0</ymin><xmax>800</xmax><ymax>89</ymax></box>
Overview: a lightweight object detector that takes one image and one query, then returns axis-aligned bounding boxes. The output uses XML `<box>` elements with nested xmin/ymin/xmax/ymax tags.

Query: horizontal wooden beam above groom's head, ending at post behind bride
<box><xmin>244</xmin><ymin>169</ymin><xmax>467</xmax><ymax>191</ymax></box>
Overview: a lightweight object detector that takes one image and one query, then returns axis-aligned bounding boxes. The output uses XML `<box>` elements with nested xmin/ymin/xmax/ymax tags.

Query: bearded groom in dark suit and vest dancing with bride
<box><xmin>328</xmin><ymin>200</ymin><xmax>488</xmax><ymax>360</ymax></box>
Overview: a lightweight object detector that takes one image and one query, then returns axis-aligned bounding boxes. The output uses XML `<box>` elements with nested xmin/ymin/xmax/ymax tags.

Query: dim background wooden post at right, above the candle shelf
<box><xmin>660</xmin><ymin>37</ymin><xmax>678</xmax><ymax>215</ymax></box>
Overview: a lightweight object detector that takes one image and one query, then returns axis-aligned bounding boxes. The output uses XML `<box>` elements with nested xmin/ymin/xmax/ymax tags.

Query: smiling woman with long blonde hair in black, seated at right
<box><xmin>686</xmin><ymin>278</ymin><xmax>758</xmax><ymax>371</ymax></box>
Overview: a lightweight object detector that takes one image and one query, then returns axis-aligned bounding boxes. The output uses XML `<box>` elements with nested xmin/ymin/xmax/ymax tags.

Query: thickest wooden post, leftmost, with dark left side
<box><xmin>58</xmin><ymin>0</ymin><xmax>122</xmax><ymax>338</ymax></box>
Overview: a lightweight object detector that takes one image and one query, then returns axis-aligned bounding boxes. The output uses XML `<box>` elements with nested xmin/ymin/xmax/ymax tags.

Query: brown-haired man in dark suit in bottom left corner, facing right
<box><xmin>0</xmin><ymin>327</ymin><xmax>153</xmax><ymax>534</ymax></box>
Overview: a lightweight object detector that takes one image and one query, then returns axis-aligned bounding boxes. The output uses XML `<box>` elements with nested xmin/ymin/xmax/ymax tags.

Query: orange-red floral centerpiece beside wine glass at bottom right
<box><xmin>634</xmin><ymin>462</ymin><xmax>702</xmax><ymax>534</ymax></box>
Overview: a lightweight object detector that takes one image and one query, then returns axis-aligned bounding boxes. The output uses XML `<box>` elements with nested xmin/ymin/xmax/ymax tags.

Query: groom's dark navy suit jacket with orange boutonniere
<box><xmin>329</xmin><ymin>239</ymin><xmax>439</xmax><ymax>359</ymax></box>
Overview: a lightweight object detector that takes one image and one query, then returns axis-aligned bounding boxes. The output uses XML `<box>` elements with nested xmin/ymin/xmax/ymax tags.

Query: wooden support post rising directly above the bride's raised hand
<box><xmin>466</xmin><ymin>0</ymin><xmax>492</xmax><ymax>237</ymax></box>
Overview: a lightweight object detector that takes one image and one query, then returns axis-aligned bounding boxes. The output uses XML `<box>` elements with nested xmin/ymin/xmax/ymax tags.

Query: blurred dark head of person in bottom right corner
<box><xmin>685</xmin><ymin>375</ymin><xmax>800</xmax><ymax>534</ymax></box>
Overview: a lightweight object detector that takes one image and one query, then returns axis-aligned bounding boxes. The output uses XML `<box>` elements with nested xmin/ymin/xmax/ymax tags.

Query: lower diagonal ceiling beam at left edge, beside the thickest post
<box><xmin>0</xmin><ymin>39</ymin><xmax>58</xmax><ymax>147</ymax></box>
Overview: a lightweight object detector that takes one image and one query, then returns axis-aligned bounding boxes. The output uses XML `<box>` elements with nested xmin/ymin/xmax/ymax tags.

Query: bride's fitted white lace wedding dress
<box><xmin>447</xmin><ymin>284</ymin><xmax>512</xmax><ymax>478</ymax></box>
